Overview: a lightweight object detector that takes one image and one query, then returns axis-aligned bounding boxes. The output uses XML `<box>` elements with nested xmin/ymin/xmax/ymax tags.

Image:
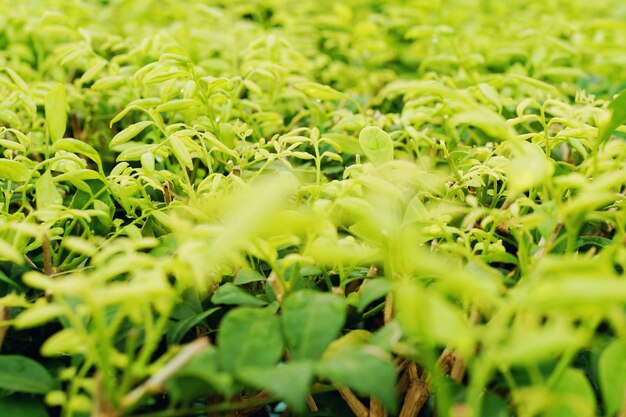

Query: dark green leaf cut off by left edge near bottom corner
<box><xmin>0</xmin><ymin>355</ymin><xmax>57</xmax><ymax>394</ymax></box>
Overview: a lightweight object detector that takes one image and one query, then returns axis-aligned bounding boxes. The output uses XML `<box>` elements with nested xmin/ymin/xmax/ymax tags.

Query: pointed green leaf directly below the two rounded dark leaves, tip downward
<box><xmin>236</xmin><ymin>362</ymin><xmax>313</xmax><ymax>414</ymax></box>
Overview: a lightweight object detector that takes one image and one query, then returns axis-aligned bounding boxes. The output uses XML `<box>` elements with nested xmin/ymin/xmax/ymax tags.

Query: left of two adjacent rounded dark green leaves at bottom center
<box><xmin>217</xmin><ymin>307</ymin><xmax>283</xmax><ymax>372</ymax></box>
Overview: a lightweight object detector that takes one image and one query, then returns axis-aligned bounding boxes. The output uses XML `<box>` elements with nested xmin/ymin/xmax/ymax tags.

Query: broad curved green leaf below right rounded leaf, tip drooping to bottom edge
<box><xmin>315</xmin><ymin>346</ymin><xmax>397</xmax><ymax>413</ymax></box>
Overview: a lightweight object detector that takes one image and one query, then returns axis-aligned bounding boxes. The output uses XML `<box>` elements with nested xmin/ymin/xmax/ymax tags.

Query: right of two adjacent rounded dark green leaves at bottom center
<box><xmin>281</xmin><ymin>290</ymin><xmax>346</xmax><ymax>360</ymax></box>
